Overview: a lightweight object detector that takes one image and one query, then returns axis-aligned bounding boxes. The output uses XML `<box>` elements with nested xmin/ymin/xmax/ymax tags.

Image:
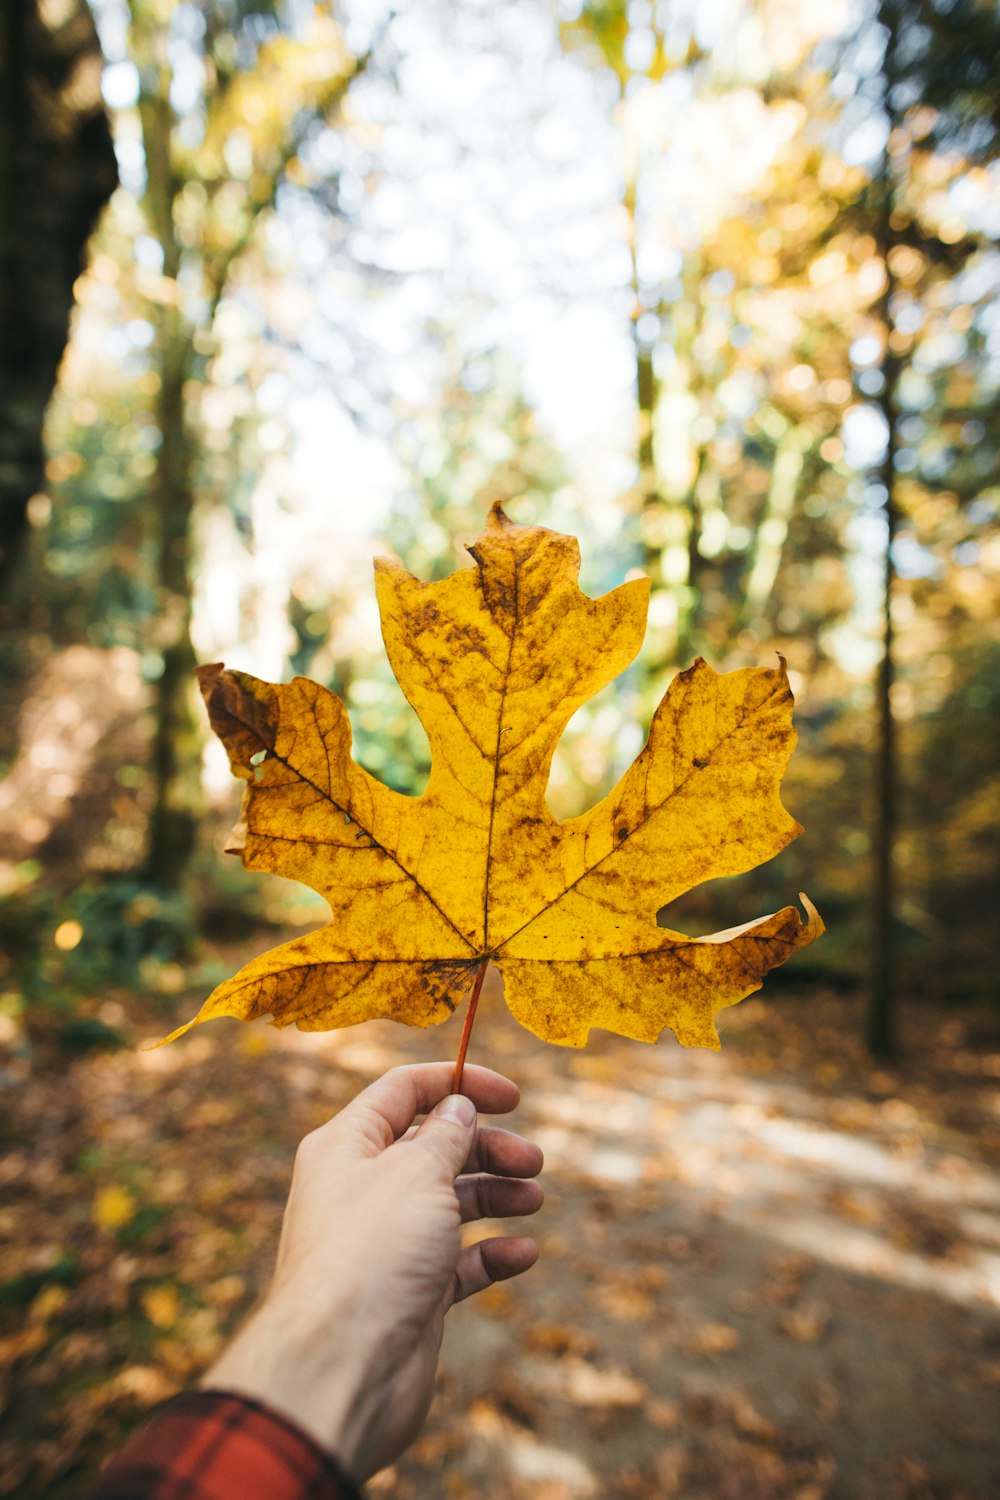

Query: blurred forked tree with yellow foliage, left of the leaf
<box><xmin>121</xmin><ymin>0</ymin><xmax>357</xmax><ymax>890</ymax></box>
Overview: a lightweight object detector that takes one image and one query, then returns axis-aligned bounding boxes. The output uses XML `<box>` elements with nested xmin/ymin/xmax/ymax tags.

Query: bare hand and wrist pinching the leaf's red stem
<box><xmin>202</xmin><ymin>1062</ymin><xmax>543</xmax><ymax>1482</ymax></box>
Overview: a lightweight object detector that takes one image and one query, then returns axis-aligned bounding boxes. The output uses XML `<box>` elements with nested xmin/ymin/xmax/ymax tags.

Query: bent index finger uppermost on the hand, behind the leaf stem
<box><xmin>334</xmin><ymin>1062</ymin><xmax>520</xmax><ymax>1151</ymax></box>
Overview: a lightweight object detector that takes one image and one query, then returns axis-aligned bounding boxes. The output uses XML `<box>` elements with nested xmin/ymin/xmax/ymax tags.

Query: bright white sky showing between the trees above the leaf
<box><xmin>277</xmin><ymin>0</ymin><xmax>634</xmax><ymax>540</ymax></box>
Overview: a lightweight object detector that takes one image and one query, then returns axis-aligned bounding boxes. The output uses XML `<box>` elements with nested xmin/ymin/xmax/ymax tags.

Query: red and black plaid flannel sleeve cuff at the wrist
<box><xmin>87</xmin><ymin>1391</ymin><xmax>358</xmax><ymax>1500</ymax></box>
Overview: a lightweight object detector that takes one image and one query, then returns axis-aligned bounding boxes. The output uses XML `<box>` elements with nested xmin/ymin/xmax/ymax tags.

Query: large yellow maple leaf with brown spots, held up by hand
<box><xmin>166</xmin><ymin>507</ymin><xmax>823</xmax><ymax>1047</ymax></box>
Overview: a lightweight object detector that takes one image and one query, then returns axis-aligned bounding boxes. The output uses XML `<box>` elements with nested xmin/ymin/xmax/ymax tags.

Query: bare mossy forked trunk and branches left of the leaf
<box><xmin>129</xmin><ymin>0</ymin><xmax>357</xmax><ymax>890</ymax></box>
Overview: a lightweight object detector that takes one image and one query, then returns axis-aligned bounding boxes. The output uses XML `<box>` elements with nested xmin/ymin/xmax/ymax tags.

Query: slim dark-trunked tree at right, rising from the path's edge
<box><xmin>850</xmin><ymin>0</ymin><xmax>1000</xmax><ymax>1059</ymax></box>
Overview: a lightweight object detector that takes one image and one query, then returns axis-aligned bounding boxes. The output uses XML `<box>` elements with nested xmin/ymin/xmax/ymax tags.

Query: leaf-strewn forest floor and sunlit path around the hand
<box><xmin>0</xmin><ymin>960</ymin><xmax>1000</xmax><ymax>1500</ymax></box>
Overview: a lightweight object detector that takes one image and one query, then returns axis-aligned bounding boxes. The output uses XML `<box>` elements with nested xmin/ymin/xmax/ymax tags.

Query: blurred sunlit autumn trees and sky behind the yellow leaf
<box><xmin>0</xmin><ymin>0</ymin><xmax>1000</xmax><ymax>1494</ymax></box>
